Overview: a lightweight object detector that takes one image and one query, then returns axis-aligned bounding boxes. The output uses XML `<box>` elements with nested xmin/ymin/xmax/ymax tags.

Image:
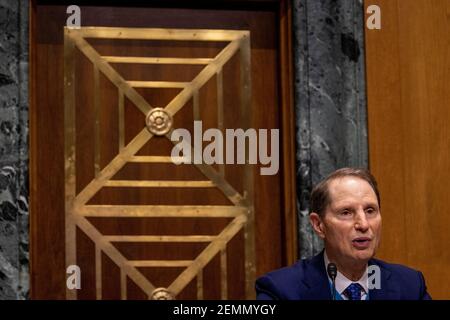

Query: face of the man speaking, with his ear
<box><xmin>311</xmin><ymin>177</ymin><xmax>381</xmax><ymax>263</ymax></box>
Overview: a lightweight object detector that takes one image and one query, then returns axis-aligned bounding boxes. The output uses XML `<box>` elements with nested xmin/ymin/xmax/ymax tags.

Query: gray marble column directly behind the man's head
<box><xmin>293</xmin><ymin>0</ymin><xmax>368</xmax><ymax>258</ymax></box>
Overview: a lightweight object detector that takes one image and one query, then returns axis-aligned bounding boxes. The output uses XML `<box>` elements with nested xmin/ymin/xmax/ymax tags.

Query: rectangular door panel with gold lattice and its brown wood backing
<box><xmin>64</xmin><ymin>27</ymin><xmax>255</xmax><ymax>299</ymax></box>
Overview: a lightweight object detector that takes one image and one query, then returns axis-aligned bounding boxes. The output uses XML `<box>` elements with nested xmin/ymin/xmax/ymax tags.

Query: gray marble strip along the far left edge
<box><xmin>0</xmin><ymin>0</ymin><xmax>29</xmax><ymax>299</ymax></box>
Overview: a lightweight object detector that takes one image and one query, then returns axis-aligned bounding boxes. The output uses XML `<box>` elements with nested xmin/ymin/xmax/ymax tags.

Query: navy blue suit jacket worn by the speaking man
<box><xmin>256</xmin><ymin>251</ymin><xmax>431</xmax><ymax>300</ymax></box>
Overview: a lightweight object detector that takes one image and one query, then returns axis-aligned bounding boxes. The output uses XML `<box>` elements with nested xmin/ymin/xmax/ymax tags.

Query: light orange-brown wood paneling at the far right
<box><xmin>365</xmin><ymin>0</ymin><xmax>450</xmax><ymax>299</ymax></box>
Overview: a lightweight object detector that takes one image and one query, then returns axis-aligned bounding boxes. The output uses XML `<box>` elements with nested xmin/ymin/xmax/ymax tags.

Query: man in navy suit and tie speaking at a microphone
<box><xmin>256</xmin><ymin>168</ymin><xmax>431</xmax><ymax>300</ymax></box>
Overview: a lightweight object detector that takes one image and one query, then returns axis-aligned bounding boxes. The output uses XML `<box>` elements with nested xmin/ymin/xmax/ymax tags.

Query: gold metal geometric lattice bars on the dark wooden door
<box><xmin>64</xmin><ymin>27</ymin><xmax>255</xmax><ymax>299</ymax></box>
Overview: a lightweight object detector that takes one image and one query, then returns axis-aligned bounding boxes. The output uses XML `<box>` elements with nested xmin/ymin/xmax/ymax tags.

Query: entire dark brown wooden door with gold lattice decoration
<box><xmin>31</xmin><ymin>2</ymin><xmax>295</xmax><ymax>299</ymax></box>
